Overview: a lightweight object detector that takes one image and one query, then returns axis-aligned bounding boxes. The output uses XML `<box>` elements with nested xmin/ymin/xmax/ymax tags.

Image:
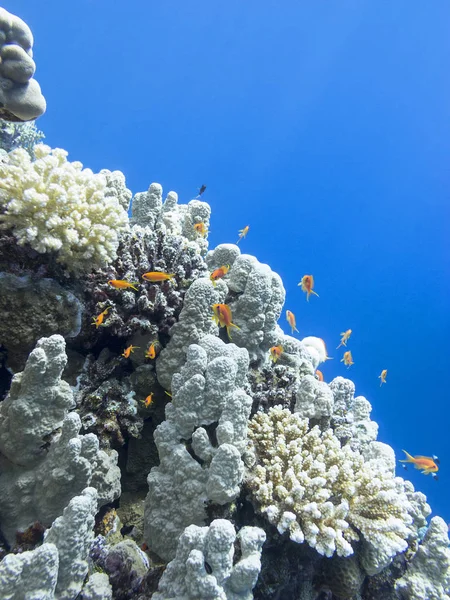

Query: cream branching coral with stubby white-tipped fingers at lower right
<box><xmin>247</xmin><ymin>407</ymin><xmax>411</xmax><ymax>559</ymax></box>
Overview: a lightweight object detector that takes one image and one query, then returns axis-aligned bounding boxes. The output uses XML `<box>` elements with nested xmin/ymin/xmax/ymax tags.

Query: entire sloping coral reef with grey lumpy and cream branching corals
<box><xmin>0</xmin><ymin>9</ymin><xmax>450</xmax><ymax>600</ymax></box>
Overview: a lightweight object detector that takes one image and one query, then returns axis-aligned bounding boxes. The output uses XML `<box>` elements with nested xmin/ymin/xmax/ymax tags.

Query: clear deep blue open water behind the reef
<box><xmin>9</xmin><ymin>0</ymin><xmax>450</xmax><ymax>520</ymax></box>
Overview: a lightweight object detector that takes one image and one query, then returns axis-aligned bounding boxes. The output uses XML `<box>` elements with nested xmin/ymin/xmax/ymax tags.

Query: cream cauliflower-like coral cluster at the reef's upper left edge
<box><xmin>0</xmin><ymin>144</ymin><xmax>129</xmax><ymax>272</ymax></box>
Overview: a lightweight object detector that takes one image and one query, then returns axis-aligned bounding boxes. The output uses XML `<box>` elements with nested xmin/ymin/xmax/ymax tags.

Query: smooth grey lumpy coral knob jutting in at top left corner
<box><xmin>0</xmin><ymin>8</ymin><xmax>46</xmax><ymax>121</ymax></box>
